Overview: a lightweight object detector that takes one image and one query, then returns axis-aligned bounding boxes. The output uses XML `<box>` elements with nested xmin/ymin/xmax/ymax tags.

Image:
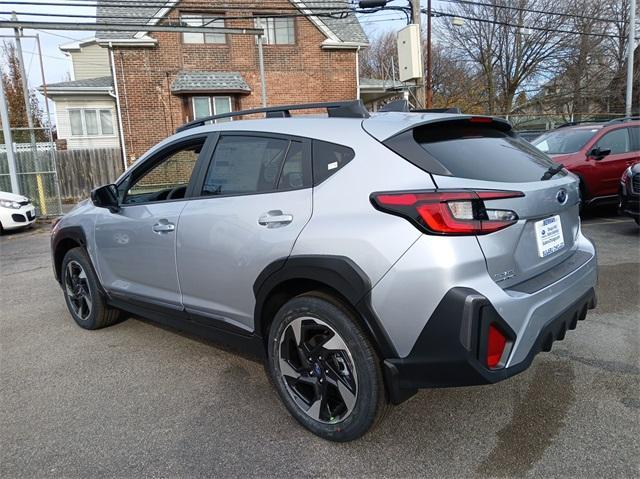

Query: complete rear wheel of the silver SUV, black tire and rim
<box><xmin>267</xmin><ymin>292</ymin><xmax>388</xmax><ymax>442</ymax></box>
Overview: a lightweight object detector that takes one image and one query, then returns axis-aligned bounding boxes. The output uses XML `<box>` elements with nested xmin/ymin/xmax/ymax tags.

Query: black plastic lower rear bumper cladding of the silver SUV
<box><xmin>383</xmin><ymin>288</ymin><xmax>597</xmax><ymax>404</ymax></box>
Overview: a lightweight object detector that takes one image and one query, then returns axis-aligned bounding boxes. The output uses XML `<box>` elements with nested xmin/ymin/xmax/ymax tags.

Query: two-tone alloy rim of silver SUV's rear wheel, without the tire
<box><xmin>278</xmin><ymin>317</ymin><xmax>358</xmax><ymax>424</ymax></box>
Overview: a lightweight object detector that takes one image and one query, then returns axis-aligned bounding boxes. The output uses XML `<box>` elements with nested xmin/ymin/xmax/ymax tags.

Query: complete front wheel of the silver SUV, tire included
<box><xmin>60</xmin><ymin>248</ymin><xmax>120</xmax><ymax>329</ymax></box>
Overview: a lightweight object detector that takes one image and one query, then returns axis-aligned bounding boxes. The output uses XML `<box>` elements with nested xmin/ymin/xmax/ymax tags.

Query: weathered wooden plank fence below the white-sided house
<box><xmin>56</xmin><ymin>148</ymin><xmax>123</xmax><ymax>202</ymax></box>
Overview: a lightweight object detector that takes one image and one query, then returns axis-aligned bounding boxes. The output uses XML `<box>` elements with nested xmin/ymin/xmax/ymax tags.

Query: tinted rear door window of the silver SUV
<box><xmin>202</xmin><ymin>135</ymin><xmax>292</xmax><ymax>196</ymax></box>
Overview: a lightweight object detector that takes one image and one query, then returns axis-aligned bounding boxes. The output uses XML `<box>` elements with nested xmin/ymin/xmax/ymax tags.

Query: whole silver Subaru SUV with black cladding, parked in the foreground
<box><xmin>52</xmin><ymin>102</ymin><xmax>597</xmax><ymax>441</ymax></box>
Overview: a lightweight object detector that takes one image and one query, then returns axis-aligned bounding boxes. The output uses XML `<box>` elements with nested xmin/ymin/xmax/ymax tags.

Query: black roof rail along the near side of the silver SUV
<box><xmin>176</xmin><ymin>100</ymin><xmax>369</xmax><ymax>133</ymax></box>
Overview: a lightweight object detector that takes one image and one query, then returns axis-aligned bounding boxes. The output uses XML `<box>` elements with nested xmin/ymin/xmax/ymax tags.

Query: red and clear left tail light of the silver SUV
<box><xmin>371</xmin><ymin>190</ymin><xmax>524</xmax><ymax>235</ymax></box>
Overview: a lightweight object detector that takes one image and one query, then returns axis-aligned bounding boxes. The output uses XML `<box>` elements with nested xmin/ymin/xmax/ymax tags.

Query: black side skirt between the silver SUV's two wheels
<box><xmin>107</xmin><ymin>297</ymin><xmax>266</xmax><ymax>360</ymax></box>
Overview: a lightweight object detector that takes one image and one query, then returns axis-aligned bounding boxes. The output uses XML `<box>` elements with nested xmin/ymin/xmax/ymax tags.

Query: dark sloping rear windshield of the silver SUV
<box><xmin>413</xmin><ymin>121</ymin><xmax>565</xmax><ymax>182</ymax></box>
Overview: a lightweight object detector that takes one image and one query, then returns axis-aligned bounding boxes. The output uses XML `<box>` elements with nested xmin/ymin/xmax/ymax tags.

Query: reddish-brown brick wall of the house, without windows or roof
<box><xmin>114</xmin><ymin>0</ymin><xmax>357</xmax><ymax>161</ymax></box>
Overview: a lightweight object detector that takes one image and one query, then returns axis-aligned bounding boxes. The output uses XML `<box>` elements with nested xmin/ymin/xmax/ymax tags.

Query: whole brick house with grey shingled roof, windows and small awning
<box><xmin>91</xmin><ymin>0</ymin><xmax>367</xmax><ymax>162</ymax></box>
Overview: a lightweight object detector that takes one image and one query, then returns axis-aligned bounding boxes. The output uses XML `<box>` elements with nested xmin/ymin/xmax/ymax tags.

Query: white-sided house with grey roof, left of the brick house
<box><xmin>39</xmin><ymin>39</ymin><xmax>120</xmax><ymax>150</ymax></box>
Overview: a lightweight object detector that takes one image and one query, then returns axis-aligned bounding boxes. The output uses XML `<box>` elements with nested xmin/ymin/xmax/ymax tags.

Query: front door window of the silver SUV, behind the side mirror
<box><xmin>122</xmin><ymin>138</ymin><xmax>205</xmax><ymax>204</ymax></box>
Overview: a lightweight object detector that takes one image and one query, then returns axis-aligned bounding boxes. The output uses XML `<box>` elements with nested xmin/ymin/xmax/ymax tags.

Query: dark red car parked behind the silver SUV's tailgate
<box><xmin>532</xmin><ymin>117</ymin><xmax>640</xmax><ymax>206</ymax></box>
